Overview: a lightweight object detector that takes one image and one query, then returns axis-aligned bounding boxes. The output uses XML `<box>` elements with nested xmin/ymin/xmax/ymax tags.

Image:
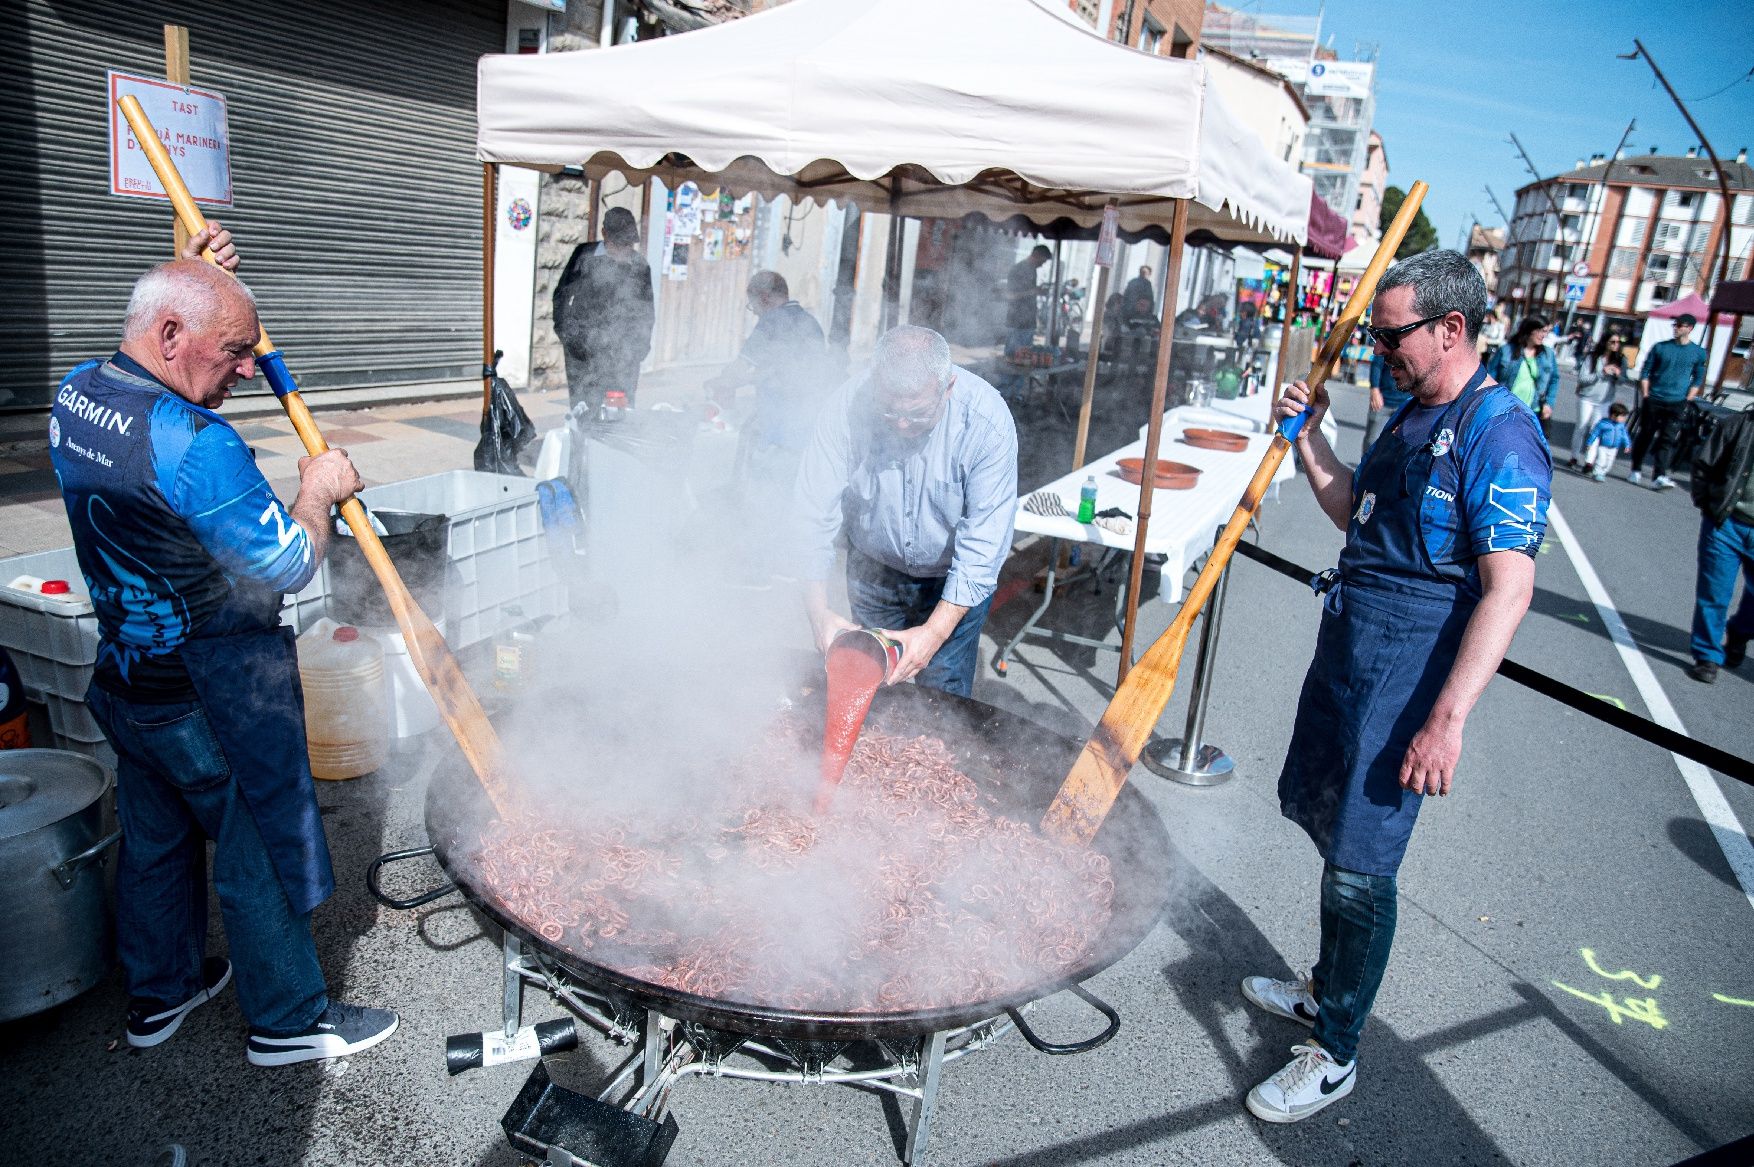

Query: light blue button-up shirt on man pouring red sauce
<box><xmin>796</xmin><ymin>369</ymin><xmax>1017</xmax><ymax>607</ymax></box>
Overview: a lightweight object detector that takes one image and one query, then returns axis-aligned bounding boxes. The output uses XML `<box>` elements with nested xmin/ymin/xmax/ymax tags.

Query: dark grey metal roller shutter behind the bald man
<box><xmin>0</xmin><ymin>0</ymin><xmax>505</xmax><ymax>409</ymax></box>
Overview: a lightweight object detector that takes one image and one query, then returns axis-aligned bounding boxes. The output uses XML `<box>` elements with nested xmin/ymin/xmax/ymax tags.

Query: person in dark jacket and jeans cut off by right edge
<box><xmin>1687</xmin><ymin>405</ymin><xmax>1754</xmax><ymax>684</ymax></box>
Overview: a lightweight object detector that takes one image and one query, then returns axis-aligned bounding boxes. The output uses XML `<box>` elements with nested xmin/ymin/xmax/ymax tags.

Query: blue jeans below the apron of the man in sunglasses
<box><xmin>1310</xmin><ymin>863</ymin><xmax>1396</xmax><ymax>1065</ymax></box>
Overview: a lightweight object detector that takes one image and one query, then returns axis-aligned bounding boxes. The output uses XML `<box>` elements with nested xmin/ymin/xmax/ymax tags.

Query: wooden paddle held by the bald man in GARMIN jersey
<box><xmin>118</xmin><ymin>97</ymin><xmax>510</xmax><ymax>820</ymax></box>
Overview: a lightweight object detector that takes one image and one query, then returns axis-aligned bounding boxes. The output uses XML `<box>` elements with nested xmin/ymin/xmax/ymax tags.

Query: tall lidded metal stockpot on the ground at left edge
<box><xmin>0</xmin><ymin>749</ymin><xmax>121</xmax><ymax>1021</ymax></box>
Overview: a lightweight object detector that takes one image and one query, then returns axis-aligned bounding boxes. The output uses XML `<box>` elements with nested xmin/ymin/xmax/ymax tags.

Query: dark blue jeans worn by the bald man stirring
<box><xmin>86</xmin><ymin>684</ymin><xmax>328</xmax><ymax>1037</ymax></box>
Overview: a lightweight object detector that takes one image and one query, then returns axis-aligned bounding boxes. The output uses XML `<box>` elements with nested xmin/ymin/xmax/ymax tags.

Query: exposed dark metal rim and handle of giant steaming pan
<box><xmin>391</xmin><ymin>684</ymin><xmax>1170</xmax><ymax>1041</ymax></box>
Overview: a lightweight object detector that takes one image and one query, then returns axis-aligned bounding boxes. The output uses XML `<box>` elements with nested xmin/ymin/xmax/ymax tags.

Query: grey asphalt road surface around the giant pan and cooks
<box><xmin>0</xmin><ymin>368</ymin><xmax>1754</xmax><ymax>1167</ymax></box>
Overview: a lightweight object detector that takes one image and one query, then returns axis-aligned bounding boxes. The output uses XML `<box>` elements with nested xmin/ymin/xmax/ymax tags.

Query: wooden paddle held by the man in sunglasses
<box><xmin>1042</xmin><ymin>183</ymin><xmax>1428</xmax><ymax>842</ymax></box>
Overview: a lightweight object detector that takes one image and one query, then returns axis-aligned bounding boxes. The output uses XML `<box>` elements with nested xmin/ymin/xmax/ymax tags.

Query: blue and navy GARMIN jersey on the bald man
<box><xmin>49</xmin><ymin>353</ymin><xmax>316</xmax><ymax>702</ymax></box>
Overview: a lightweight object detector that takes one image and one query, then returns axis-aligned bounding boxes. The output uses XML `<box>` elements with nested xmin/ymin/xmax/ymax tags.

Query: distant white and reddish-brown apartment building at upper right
<box><xmin>1496</xmin><ymin>149</ymin><xmax>1754</xmax><ymax>329</ymax></box>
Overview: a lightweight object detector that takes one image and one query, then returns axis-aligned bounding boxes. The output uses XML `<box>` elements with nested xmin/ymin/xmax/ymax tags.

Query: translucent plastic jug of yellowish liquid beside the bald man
<box><xmin>298</xmin><ymin>616</ymin><xmax>389</xmax><ymax>781</ymax></box>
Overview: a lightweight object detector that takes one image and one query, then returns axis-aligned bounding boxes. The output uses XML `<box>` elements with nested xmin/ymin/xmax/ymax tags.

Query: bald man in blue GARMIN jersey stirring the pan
<box><xmin>49</xmin><ymin>223</ymin><xmax>396</xmax><ymax>1065</ymax></box>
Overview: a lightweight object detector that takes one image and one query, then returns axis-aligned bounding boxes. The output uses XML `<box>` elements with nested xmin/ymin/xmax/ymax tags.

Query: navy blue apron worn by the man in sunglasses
<box><xmin>1279</xmin><ymin>369</ymin><xmax>1486</xmax><ymax>876</ymax></box>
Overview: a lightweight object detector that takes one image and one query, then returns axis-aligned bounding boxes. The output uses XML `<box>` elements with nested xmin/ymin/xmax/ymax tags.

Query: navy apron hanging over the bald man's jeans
<box><xmin>179</xmin><ymin>625</ymin><xmax>335</xmax><ymax>916</ymax></box>
